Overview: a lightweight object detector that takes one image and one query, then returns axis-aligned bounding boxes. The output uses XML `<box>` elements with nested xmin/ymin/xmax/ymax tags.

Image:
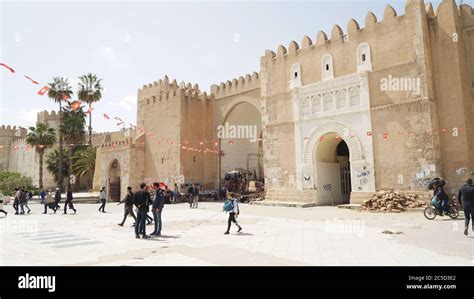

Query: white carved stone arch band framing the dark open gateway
<box><xmin>303</xmin><ymin>121</ymin><xmax>364</xmax><ymax>164</ymax></box>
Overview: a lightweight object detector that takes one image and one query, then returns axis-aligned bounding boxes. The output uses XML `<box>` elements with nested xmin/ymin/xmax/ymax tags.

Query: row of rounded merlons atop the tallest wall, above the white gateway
<box><xmin>262</xmin><ymin>0</ymin><xmax>438</xmax><ymax>61</ymax></box>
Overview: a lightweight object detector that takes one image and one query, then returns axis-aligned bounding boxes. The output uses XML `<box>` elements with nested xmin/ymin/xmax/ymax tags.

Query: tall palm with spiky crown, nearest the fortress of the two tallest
<box><xmin>77</xmin><ymin>73</ymin><xmax>103</xmax><ymax>144</ymax></box>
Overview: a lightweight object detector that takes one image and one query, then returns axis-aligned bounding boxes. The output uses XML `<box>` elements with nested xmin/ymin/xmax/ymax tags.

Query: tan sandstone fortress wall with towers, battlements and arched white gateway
<box><xmin>1</xmin><ymin>0</ymin><xmax>474</xmax><ymax>205</ymax></box>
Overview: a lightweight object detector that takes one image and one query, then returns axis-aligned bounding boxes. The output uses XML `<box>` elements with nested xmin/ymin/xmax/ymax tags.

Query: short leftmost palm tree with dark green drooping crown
<box><xmin>26</xmin><ymin>122</ymin><xmax>56</xmax><ymax>189</ymax></box>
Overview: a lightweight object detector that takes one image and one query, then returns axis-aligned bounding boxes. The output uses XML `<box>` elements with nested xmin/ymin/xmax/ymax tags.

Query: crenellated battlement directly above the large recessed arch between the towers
<box><xmin>211</xmin><ymin>72</ymin><xmax>260</xmax><ymax>99</ymax></box>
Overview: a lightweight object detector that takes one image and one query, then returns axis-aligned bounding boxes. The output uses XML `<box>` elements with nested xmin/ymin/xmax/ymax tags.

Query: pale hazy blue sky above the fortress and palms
<box><xmin>0</xmin><ymin>0</ymin><xmax>460</xmax><ymax>131</ymax></box>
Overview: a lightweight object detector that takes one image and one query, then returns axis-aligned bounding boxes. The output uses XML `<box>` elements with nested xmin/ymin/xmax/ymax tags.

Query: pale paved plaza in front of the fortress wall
<box><xmin>0</xmin><ymin>203</ymin><xmax>474</xmax><ymax>266</ymax></box>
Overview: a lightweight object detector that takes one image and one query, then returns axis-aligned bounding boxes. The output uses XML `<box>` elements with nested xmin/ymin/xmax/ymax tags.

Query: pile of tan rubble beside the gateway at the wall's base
<box><xmin>361</xmin><ymin>190</ymin><xmax>426</xmax><ymax>213</ymax></box>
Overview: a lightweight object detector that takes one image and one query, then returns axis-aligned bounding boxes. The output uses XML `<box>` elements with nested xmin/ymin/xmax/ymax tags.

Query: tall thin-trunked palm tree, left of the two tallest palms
<box><xmin>48</xmin><ymin>77</ymin><xmax>72</xmax><ymax>190</ymax></box>
